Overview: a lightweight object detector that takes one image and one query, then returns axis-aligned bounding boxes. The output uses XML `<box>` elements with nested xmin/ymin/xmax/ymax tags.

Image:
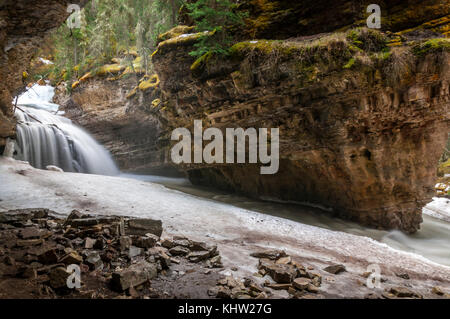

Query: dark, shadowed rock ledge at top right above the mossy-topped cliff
<box><xmin>238</xmin><ymin>0</ymin><xmax>450</xmax><ymax>39</ymax></box>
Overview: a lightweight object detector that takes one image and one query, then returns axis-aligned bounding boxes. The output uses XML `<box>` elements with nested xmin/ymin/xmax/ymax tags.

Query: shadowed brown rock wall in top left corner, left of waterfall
<box><xmin>0</xmin><ymin>0</ymin><xmax>87</xmax><ymax>153</ymax></box>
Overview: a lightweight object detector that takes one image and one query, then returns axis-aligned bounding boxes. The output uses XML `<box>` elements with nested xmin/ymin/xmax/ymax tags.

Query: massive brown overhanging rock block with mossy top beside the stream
<box><xmin>153</xmin><ymin>22</ymin><xmax>450</xmax><ymax>232</ymax></box>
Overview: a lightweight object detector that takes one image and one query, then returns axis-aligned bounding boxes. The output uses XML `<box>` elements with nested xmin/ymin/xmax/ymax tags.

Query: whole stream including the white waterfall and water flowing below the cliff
<box><xmin>10</xmin><ymin>85</ymin><xmax>450</xmax><ymax>266</ymax></box>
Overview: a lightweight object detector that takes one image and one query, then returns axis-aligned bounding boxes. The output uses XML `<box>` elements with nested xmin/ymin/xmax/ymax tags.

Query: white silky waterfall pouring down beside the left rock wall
<box><xmin>15</xmin><ymin>84</ymin><xmax>119</xmax><ymax>175</ymax></box>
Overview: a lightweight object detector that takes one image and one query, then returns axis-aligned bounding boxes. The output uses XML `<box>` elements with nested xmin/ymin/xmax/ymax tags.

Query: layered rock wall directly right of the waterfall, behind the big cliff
<box><xmin>56</xmin><ymin>77</ymin><xmax>167</xmax><ymax>171</ymax></box>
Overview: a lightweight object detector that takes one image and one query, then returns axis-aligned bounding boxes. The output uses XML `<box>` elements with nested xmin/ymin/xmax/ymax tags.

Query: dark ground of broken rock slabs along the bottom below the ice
<box><xmin>0</xmin><ymin>208</ymin><xmax>450</xmax><ymax>299</ymax></box>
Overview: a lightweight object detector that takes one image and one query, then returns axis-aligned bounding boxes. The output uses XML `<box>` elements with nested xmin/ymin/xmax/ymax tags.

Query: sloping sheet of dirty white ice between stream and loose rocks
<box><xmin>0</xmin><ymin>158</ymin><xmax>450</xmax><ymax>297</ymax></box>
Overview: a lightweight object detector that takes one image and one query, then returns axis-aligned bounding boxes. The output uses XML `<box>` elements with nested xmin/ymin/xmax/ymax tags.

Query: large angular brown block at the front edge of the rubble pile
<box><xmin>111</xmin><ymin>261</ymin><xmax>157</xmax><ymax>291</ymax></box>
